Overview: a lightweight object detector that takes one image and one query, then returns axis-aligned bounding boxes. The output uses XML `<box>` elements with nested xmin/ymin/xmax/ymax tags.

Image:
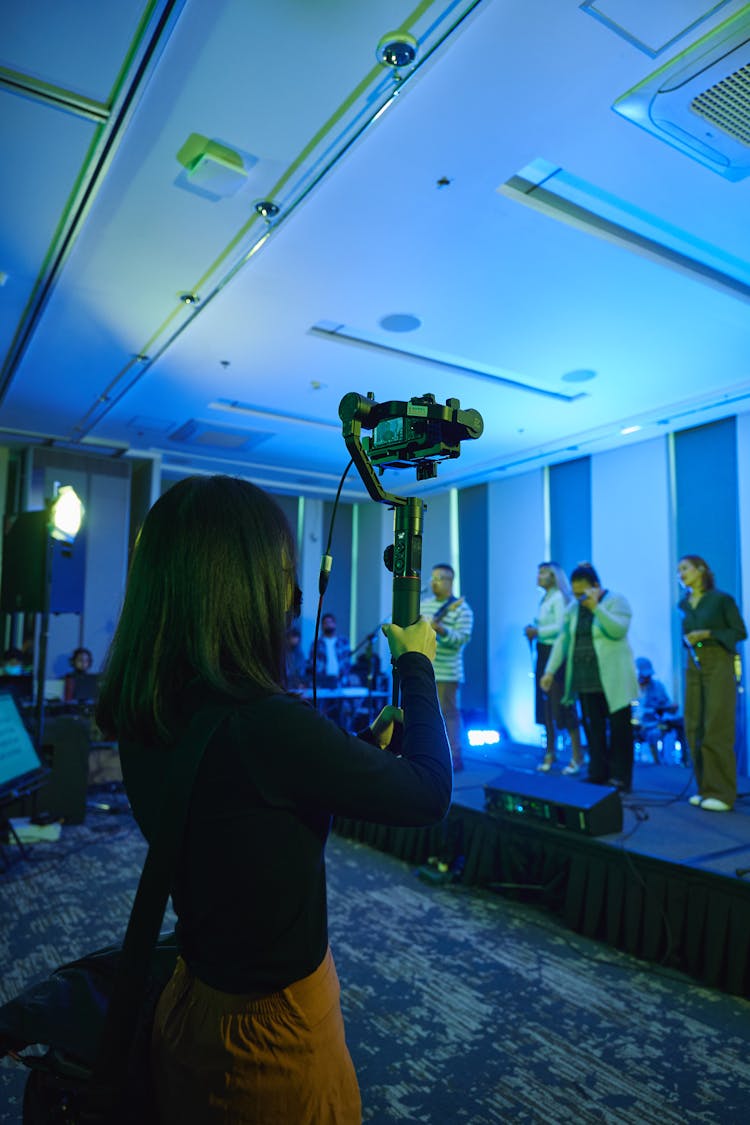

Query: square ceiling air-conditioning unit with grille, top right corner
<box><xmin>612</xmin><ymin>5</ymin><xmax>750</xmax><ymax>180</ymax></box>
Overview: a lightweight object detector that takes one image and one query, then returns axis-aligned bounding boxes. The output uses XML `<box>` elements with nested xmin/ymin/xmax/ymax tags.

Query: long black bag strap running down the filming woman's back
<box><xmin>94</xmin><ymin>707</ymin><xmax>234</xmax><ymax>1083</ymax></box>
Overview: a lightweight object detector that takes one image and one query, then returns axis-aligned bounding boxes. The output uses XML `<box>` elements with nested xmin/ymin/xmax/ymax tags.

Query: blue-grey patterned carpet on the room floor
<box><xmin>0</xmin><ymin>813</ymin><xmax>750</xmax><ymax>1125</ymax></box>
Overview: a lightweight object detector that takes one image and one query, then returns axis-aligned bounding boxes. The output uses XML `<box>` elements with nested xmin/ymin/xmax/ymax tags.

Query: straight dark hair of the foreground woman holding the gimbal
<box><xmin>97</xmin><ymin>476</ymin><xmax>296</xmax><ymax>744</ymax></box>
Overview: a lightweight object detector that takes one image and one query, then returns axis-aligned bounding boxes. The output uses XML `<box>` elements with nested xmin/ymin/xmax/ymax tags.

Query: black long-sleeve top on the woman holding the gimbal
<box><xmin>120</xmin><ymin>653</ymin><xmax>452</xmax><ymax>992</ymax></box>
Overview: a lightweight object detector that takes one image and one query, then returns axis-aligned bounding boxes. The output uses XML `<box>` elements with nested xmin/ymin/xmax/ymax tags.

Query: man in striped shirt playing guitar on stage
<box><xmin>422</xmin><ymin>563</ymin><xmax>475</xmax><ymax>773</ymax></box>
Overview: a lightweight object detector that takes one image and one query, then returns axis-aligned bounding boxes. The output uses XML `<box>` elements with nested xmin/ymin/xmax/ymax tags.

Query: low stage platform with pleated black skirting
<box><xmin>334</xmin><ymin>745</ymin><xmax>750</xmax><ymax>997</ymax></box>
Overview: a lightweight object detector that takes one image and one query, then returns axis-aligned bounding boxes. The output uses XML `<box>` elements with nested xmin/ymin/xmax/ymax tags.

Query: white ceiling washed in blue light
<box><xmin>0</xmin><ymin>0</ymin><xmax>750</xmax><ymax>493</ymax></box>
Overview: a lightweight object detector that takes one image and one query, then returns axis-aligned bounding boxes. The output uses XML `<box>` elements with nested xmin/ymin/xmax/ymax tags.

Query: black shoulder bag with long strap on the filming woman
<box><xmin>0</xmin><ymin>708</ymin><xmax>229</xmax><ymax>1125</ymax></box>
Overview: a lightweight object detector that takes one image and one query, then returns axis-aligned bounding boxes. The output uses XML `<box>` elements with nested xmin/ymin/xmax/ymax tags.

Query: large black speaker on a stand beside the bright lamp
<box><xmin>0</xmin><ymin>510</ymin><xmax>85</xmax><ymax>613</ymax></box>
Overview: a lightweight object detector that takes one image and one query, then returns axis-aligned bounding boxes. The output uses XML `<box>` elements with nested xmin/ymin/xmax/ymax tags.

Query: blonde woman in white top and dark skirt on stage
<box><xmin>524</xmin><ymin>563</ymin><xmax>584</xmax><ymax>775</ymax></box>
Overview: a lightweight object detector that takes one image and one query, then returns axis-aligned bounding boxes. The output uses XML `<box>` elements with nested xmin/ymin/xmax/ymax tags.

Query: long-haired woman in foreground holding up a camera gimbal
<box><xmin>97</xmin><ymin>476</ymin><xmax>451</xmax><ymax>1125</ymax></box>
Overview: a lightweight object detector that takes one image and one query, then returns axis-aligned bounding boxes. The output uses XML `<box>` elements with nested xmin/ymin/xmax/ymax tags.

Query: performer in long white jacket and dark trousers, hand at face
<box><xmin>540</xmin><ymin>563</ymin><xmax>638</xmax><ymax>792</ymax></box>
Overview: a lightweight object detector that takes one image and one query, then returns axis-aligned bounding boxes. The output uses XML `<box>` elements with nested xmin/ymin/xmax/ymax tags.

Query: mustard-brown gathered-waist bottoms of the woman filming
<box><xmin>152</xmin><ymin>950</ymin><xmax>362</xmax><ymax>1125</ymax></box>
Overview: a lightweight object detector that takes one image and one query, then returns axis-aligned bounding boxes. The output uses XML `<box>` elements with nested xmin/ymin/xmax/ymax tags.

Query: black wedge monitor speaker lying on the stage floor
<box><xmin>485</xmin><ymin>770</ymin><xmax>623</xmax><ymax>836</ymax></box>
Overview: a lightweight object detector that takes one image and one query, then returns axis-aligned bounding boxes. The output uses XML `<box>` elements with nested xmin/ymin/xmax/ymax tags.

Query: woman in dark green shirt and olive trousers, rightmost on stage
<box><xmin>677</xmin><ymin>555</ymin><xmax>748</xmax><ymax>812</ymax></box>
